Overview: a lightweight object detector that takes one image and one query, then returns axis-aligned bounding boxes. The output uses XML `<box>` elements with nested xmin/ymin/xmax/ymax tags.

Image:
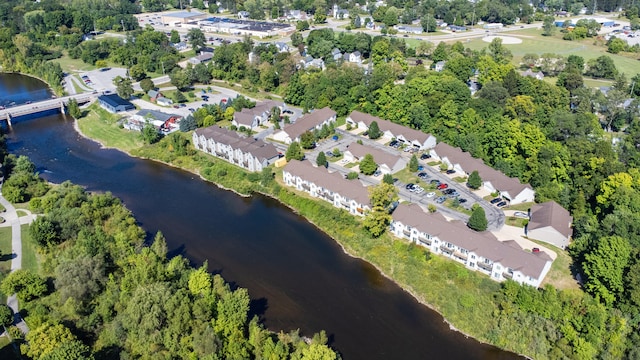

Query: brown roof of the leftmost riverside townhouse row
<box><xmin>196</xmin><ymin>125</ymin><xmax>279</xmax><ymax>160</ymax></box>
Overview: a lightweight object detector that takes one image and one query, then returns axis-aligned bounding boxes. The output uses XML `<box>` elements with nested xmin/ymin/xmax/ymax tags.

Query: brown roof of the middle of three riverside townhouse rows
<box><xmin>284</xmin><ymin>160</ymin><xmax>371</xmax><ymax>206</ymax></box>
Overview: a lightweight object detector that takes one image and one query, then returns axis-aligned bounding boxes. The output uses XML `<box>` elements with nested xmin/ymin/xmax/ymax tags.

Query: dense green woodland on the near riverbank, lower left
<box><xmin>1</xmin><ymin>181</ymin><xmax>337</xmax><ymax>359</ymax></box>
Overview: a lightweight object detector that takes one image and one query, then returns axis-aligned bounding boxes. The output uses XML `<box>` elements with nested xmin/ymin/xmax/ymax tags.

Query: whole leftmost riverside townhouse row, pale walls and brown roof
<box><xmin>192</xmin><ymin>125</ymin><xmax>280</xmax><ymax>172</ymax></box>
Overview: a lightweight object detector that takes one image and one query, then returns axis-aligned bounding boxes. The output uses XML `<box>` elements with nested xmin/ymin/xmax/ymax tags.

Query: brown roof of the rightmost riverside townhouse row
<box><xmin>393</xmin><ymin>204</ymin><xmax>547</xmax><ymax>278</ymax></box>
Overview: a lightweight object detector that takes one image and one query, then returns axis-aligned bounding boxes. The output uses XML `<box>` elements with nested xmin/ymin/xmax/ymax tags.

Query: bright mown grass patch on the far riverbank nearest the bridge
<box><xmin>78</xmin><ymin>104</ymin><xmax>142</xmax><ymax>151</ymax></box>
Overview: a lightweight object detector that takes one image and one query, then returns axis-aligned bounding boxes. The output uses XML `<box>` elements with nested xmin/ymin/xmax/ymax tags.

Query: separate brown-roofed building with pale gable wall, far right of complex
<box><xmin>525</xmin><ymin>201</ymin><xmax>573</xmax><ymax>249</ymax></box>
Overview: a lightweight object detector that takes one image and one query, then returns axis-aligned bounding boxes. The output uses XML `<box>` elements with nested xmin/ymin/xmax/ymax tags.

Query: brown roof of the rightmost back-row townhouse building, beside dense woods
<box><xmin>433</xmin><ymin>142</ymin><xmax>531</xmax><ymax>196</ymax></box>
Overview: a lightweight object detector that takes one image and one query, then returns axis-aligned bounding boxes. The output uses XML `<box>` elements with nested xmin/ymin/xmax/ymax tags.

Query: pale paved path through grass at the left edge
<box><xmin>0</xmin><ymin>187</ymin><xmax>35</xmax><ymax>334</ymax></box>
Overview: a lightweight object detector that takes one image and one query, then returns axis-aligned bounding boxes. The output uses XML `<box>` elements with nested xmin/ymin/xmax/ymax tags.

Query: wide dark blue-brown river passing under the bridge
<box><xmin>0</xmin><ymin>75</ymin><xmax>517</xmax><ymax>360</ymax></box>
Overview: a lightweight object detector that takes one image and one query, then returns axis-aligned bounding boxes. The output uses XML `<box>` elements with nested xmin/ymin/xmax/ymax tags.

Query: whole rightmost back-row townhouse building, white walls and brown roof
<box><xmin>430</xmin><ymin>142</ymin><xmax>535</xmax><ymax>204</ymax></box>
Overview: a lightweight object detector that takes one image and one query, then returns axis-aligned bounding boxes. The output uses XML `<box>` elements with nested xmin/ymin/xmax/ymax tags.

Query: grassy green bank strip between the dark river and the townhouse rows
<box><xmin>74</xmin><ymin>119</ymin><xmax>536</xmax><ymax>358</ymax></box>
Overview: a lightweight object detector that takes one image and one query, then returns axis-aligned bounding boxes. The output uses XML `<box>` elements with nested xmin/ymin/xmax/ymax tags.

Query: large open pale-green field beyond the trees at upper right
<box><xmin>464</xmin><ymin>29</ymin><xmax>640</xmax><ymax>78</ymax></box>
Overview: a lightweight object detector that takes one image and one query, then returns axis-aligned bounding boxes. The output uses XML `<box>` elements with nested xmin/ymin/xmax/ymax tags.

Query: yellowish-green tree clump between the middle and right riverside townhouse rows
<box><xmin>362</xmin><ymin>182</ymin><xmax>398</xmax><ymax>238</ymax></box>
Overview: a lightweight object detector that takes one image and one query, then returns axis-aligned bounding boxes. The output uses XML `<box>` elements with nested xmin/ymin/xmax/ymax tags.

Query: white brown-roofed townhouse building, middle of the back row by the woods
<box><xmin>346</xmin><ymin>110</ymin><xmax>436</xmax><ymax>150</ymax></box>
